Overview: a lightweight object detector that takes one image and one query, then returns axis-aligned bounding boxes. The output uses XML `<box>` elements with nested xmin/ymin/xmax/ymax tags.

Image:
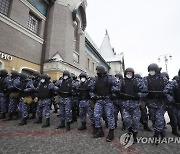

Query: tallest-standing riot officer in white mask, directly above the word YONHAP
<box><xmin>143</xmin><ymin>63</ymin><xmax>168</xmax><ymax>145</ymax></box>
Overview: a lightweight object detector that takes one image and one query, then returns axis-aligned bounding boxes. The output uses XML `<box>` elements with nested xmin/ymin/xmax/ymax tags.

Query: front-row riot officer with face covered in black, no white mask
<box><xmin>90</xmin><ymin>66</ymin><xmax>116</xmax><ymax>142</ymax></box>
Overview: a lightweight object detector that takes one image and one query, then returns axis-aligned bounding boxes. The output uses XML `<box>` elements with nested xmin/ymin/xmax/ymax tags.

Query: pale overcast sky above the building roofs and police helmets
<box><xmin>86</xmin><ymin>0</ymin><xmax>180</xmax><ymax>78</ymax></box>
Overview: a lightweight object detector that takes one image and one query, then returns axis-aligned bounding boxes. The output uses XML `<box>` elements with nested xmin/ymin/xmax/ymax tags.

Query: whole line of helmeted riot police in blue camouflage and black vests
<box><xmin>0</xmin><ymin>63</ymin><xmax>180</xmax><ymax>144</ymax></box>
